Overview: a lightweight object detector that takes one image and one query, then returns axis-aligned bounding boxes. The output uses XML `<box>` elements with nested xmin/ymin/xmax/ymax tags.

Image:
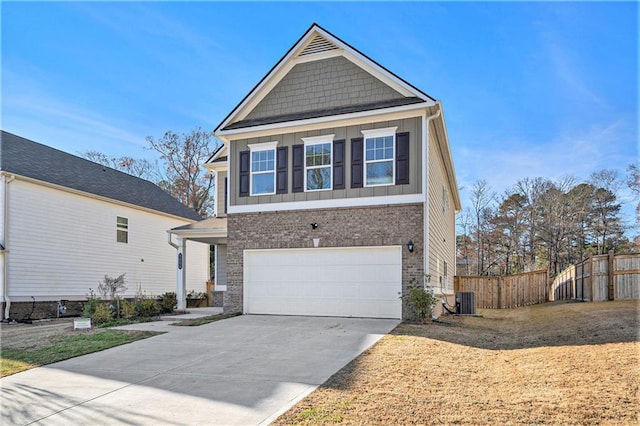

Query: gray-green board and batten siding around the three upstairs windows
<box><xmin>229</xmin><ymin>117</ymin><xmax>422</xmax><ymax>206</ymax></box>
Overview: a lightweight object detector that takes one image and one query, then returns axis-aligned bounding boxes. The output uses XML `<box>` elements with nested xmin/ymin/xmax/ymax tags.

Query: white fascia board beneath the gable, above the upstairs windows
<box><xmin>218</xmin><ymin>102</ymin><xmax>431</xmax><ymax>139</ymax></box>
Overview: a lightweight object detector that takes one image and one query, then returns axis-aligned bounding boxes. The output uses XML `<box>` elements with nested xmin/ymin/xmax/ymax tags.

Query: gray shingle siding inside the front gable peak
<box><xmin>245</xmin><ymin>56</ymin><xmax>404</xmax><ymax>120</ymax></box>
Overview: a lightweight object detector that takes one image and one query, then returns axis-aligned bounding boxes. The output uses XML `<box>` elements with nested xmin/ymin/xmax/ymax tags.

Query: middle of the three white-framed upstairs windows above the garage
<box><xmin>302</xmin><ymin>135</ymin><xmax>334</xmax><ymax>191</ymax></box>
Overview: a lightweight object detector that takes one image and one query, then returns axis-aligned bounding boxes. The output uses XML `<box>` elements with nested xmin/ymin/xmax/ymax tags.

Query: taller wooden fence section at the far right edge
<box><xmin>549</xmin><ymin>252</ymin><xmax>640</xmax><ymax>302</ymax></box>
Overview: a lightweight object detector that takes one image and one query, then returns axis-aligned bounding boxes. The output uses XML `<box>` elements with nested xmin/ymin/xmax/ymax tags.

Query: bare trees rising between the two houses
<box><xmin>80</xmin><ymin>128</ymin><xmax>219</xmax><ymax>218</ymax></box>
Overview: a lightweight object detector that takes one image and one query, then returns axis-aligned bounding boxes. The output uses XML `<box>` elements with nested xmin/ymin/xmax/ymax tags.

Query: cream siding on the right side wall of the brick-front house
<box><xmin>427</xmin><ymin>124</ymin><xmax>456</xmax><ymax>293</ymax></box>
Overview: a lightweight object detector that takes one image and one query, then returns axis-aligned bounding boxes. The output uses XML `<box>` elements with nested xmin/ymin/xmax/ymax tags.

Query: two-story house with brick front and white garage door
<box><xmin>172</xmin><ymin>24</ymin><xmax>460</xmax><ymax>318</ymax></box>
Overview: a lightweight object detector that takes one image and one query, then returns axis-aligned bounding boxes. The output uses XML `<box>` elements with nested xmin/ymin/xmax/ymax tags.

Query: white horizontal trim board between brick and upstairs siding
<box><xmin>227</xmin><ymin>194</ymin><xmax>425</xmax><ymax>214</ymax></box>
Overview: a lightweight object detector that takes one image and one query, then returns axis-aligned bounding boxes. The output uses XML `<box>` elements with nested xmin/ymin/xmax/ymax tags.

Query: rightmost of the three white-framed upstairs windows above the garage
<box><xmin>362</xmin><ymin>127</ymin><xmax>397</xmax><ymax>186</ymax></box>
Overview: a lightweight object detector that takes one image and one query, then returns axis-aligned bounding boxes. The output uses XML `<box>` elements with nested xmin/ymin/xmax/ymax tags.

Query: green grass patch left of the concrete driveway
<box><xmin>0</xmin><ymin>330</ymin><xmax>160</xmax><ymax>377</ymax></box>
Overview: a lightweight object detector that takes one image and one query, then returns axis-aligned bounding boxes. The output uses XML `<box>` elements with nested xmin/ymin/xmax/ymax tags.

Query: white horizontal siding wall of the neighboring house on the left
<box><xmin>3</xmin><ymin>180</ymin><xmax>209</xmax><ymax>302</ymax></box>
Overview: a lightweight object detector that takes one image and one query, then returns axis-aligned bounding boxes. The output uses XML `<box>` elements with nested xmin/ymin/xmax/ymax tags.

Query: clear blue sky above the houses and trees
<box><xmin>0</xmin><ymin>2</ymin><xmax>639</xmax><ymax>228</ymax></box>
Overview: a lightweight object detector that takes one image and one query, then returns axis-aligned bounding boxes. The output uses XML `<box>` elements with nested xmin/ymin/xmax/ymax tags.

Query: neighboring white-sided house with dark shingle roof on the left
<box><xmin>0</xmin><ymin>131</ymin><xmax>209</xmax><ymax>319</ymax></box>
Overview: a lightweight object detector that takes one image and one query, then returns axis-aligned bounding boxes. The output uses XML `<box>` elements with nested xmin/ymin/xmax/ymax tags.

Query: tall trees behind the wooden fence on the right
<box><xmin>456</xmin><ymin>164</ymin><xmax>640</xmax><ymax>276</ymax></box>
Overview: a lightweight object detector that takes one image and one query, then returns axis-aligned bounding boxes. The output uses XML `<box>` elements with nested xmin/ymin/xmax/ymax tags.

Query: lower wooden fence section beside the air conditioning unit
<box><xmin>453</xmin><ymin>270</ymin><xmax>548</xmax><ymax>308</ymax></box>
